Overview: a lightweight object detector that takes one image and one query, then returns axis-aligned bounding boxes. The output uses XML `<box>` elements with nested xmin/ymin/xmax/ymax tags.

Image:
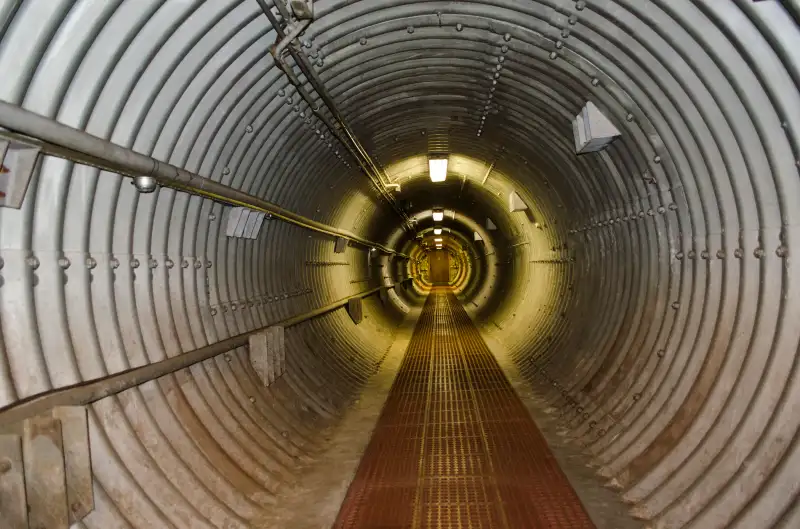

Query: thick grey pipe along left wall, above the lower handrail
<box><xmin>0</xmin><ymin>101</ymin><xmax>407</xmax><ymax>257</ymax></box>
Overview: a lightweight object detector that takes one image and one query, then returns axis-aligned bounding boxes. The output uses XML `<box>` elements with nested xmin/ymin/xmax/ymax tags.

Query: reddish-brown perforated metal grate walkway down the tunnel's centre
<box><xmin>334</xmin><ymin>288</ymin><xmax>594</xmax><ymax>529</ymax></box>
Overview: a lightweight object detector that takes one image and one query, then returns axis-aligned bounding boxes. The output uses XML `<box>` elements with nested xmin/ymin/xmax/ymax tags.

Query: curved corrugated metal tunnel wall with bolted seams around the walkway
<box><xmin>0</xmin><ymin>0</ymin><xmax>800</xmax><ymax>529</ymax></box>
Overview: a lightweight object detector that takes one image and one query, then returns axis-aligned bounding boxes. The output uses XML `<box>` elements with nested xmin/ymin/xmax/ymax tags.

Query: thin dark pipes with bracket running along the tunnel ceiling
<box><xmin>256</xmin><ymin>0</ymin><xmax>411</xmax><ymax>230</ymax></box>
